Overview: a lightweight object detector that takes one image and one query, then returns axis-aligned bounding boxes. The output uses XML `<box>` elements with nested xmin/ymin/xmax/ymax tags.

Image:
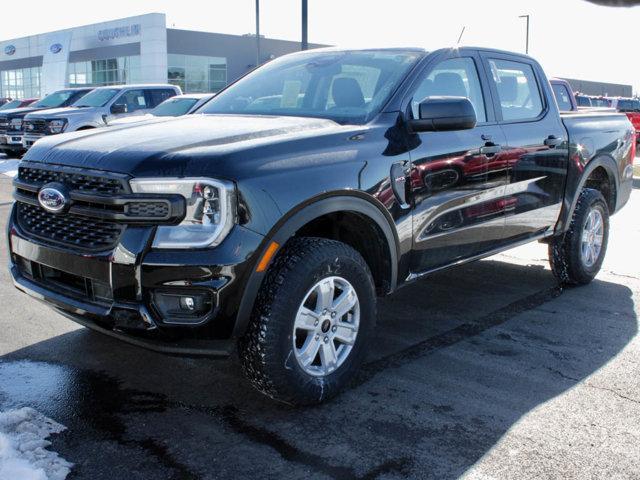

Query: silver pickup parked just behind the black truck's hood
<box><xmin>23</xmin><ymin>85</ymin><xmax>182</xmax><ymax>150</ymax></box>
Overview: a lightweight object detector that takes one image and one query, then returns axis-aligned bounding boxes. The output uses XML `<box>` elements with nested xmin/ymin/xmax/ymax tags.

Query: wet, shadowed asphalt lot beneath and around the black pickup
<box><xmin>0</xmin><ymin>155</ymin><xmax>640</xmax><ymax>480</ymax></box>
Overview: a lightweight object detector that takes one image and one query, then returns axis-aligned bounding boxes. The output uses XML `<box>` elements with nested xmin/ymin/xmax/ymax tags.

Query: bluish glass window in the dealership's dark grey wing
<box><xmin>167</xmin><ymin>53</ymin><xmax>227</xmax><ymax>93</ymax></box>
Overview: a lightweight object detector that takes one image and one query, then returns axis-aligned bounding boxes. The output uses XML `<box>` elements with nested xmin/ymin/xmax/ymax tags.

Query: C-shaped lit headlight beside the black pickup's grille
<box><xmin>129</xmin><ymin>178</ymin><xmax>236</xmax><ymax>248</ymax></box>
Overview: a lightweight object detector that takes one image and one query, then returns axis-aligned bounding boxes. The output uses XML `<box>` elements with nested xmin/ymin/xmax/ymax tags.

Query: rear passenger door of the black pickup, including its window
<box><xmin>481</xmin><ymin>52</ymin><xmax>568</xmax><ymax>241</ymax></box>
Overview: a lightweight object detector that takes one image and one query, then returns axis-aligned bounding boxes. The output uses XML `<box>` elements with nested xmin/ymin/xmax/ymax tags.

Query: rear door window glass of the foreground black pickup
<box><xmin>489</xmin><ymin>59</ymin><xmax>543</xmax><ymax>122</ymax></box>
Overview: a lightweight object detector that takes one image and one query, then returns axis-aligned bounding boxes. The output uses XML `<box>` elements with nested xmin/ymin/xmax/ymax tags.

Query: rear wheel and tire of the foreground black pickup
<box><xmin>549</xmin><ymin>188</ymin><xmax>609</xmax><ymax>285</ymax></box>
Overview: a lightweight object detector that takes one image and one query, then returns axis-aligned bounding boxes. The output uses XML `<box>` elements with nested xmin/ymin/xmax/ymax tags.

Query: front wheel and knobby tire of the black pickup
<box><xmin>239</xmin><ymin>237</ymin><xmax>376</xmax><ymax>405</ymax></box>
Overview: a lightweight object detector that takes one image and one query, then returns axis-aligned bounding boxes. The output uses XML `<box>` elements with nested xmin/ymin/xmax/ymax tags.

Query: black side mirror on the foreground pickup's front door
<box><xmin>410</xmin><ymin>97</ymin><xmax>477</xmax><ymax>132</ymax></box>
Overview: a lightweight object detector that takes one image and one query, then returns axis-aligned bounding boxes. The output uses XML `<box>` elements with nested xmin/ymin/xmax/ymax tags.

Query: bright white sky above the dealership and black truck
<box><xmin>0</xmin><ymin>0</ymin><xmax>640</xmax><ymax>92</ymax></box>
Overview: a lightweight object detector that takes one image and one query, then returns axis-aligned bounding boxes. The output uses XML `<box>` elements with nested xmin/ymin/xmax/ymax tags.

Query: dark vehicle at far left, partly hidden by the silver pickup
<box><xmin>0</xmin><ymin>87</ymin><xmax>92</xmax><ymax>157</ymax></box>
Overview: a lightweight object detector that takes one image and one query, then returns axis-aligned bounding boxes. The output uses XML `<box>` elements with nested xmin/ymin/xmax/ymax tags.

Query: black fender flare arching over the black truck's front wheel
<box><xmin>233</xmin><ymin>191</ymin><xmax>399</xmax><ymax>338</ymax></box>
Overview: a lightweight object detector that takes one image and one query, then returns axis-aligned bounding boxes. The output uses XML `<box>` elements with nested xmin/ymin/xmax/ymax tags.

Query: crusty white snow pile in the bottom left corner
<box><xmin>0</xmin><ymin>407</ymin><xmax>72</xmax><ymax>480</ymax></box>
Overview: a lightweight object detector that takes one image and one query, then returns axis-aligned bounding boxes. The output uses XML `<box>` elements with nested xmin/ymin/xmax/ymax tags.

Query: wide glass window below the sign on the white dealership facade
<box><xmin>69</xmin><ymin>55</ymin><xmax>141</xmax><ymax>87</ymax></box>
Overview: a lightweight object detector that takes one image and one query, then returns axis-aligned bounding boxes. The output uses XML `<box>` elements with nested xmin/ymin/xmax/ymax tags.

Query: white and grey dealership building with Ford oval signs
<box><xmin>0</xmin><ymin>13</ymin><xmax>319</xmax><ymax>98</ymax></box>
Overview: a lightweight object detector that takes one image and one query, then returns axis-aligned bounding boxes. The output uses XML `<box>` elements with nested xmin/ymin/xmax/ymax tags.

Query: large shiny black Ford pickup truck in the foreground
<box><xmin>8</xmin><ymin>48</ymin><xmax>636</xmax><ymax>404</ymax></box>
